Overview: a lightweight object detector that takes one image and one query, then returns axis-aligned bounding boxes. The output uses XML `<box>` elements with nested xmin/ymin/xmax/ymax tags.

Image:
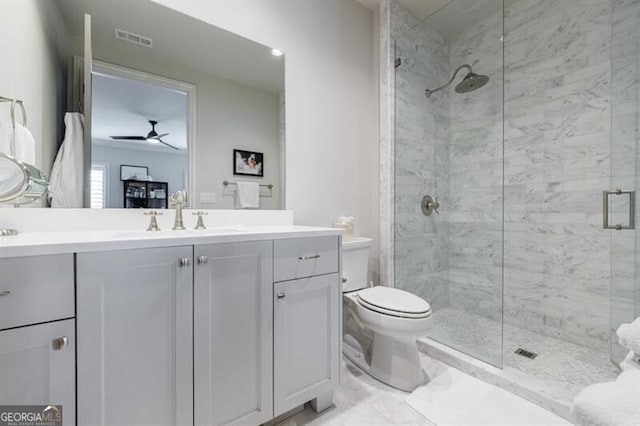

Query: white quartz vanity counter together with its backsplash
<box><xmin>0</xmin><ymin>208</ymin><xmax>342</xmax><ymax>258</ymax></box>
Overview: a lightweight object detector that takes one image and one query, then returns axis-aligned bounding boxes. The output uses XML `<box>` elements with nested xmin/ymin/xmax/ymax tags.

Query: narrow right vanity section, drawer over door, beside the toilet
<box><xmin>273</xmin><ymin>237</ymin><xmax>342</xmax><ymax>416</ymax></box>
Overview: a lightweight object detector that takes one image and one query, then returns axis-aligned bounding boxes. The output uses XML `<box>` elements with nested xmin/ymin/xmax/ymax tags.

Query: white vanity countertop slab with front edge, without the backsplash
<box><xmin>0</xmin><ymin>225</ymin><xmax>342</xmax><ymax>258</ymax></box>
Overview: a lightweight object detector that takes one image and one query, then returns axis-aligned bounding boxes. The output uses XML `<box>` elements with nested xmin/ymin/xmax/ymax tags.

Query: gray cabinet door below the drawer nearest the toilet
<box><xmin>273</xmin><ymin>274</ymin><xmax>341</xmax><ymax>416</ymax></box>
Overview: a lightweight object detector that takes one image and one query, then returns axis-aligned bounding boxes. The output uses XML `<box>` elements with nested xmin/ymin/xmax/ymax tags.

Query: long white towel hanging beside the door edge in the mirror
<box><xmin>47</xmin><ymin>112</ymin><xmax>84</xmax><ymax>208</ymax></box>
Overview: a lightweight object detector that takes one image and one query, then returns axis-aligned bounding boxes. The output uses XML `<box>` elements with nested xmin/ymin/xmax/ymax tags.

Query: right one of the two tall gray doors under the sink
<box><xmin>194</xmin><ymin>241</ymin><xmax>273</xmax><ymax>425</ymax></box>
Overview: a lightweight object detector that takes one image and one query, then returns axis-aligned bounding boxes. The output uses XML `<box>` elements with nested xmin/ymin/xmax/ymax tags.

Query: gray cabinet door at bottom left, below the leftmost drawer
<box><xmin>0</xmin><ymin>319</ymin><xmax>76</xmax><ymax>425</ymax></box>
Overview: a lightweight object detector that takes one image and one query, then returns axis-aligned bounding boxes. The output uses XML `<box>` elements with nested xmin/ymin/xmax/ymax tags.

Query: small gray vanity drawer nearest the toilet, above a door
<box><xmin>273</xmin><ymin>237</ymin><xmax>338</xmax><ymax>281</ymax></box>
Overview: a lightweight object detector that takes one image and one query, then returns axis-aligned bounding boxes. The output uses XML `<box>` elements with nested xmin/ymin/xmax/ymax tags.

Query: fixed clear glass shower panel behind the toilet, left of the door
<box><xmin>394</xmin><ymin>0</ymin><xmax>504</xmax><ymax>366</ymax></box>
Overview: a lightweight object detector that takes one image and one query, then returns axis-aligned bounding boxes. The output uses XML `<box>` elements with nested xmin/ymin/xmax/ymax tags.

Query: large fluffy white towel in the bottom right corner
<box><xmin>571</xmin><ymin>370</ymin><xmax>640</xmax><ymax>426</ymax></box>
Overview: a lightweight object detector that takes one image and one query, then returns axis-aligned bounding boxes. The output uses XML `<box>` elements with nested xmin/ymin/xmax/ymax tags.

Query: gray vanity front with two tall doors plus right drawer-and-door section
<box><xmin>69</xmin><ymin>236</ymin><xmax>342</xmax><ymax>425</ymax></box>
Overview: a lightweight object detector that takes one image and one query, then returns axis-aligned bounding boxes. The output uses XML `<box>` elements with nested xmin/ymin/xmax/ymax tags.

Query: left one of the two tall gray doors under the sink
<box><xmin>76</xmin><ymin>246</ymin><xmax>193</xmax><ymax>425</ymax></box>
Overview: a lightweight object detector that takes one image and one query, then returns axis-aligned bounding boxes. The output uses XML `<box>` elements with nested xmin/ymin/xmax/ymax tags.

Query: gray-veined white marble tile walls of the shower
<box><xmin>381</xmin><ymin>0</ymin><xmax>624</xmax><ymax>351</ymax></box>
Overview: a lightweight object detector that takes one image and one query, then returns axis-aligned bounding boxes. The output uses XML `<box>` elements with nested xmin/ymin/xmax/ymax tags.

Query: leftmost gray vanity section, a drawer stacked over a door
<box><xmin>0</xmin><ymin>254</ymin><xmax>76</xmax><ymax>425</ymax></box>
